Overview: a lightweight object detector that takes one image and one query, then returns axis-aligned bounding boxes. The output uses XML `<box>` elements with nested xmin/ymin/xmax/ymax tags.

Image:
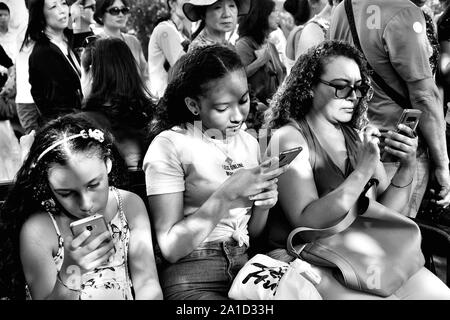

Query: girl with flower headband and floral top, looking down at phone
<box><xmin>0</xmin><ymin>115</ymin><xmax>162</xmax><ymax>300</ymax></box>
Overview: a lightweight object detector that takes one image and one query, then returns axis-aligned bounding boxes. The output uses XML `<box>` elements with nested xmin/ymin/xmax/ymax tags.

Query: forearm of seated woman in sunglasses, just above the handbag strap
<box><xmin>296</xmin><ymin>170</ymin><xmax>371</xmax><ymax>228</ymax></box>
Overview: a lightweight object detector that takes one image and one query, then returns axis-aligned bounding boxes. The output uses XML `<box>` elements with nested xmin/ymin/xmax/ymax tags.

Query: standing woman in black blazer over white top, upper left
<box><xmin>22</xmin><ymin>0</ymin><xmax>83</xmax><ymax>125</ymax></box>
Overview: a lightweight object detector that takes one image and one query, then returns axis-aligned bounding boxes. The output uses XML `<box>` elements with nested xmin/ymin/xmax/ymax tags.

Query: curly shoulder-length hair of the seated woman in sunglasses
<box><xmin>264</xmin><ymin>41</ymin><xmax>373</xmax><ymax>129</ymax></box>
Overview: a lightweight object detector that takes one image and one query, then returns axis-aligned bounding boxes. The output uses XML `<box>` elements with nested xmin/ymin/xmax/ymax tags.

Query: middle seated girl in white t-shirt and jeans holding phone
<box><xmin>144</xmin><ymin>45</ymin><xmax>285</xmax><ymax>300</ymax></box>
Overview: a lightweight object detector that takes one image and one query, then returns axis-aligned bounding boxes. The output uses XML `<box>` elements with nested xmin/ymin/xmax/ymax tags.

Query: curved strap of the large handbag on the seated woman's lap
<box><xmin>286</xmin><ymin>178</ymin><xmax>378</xmax><ymax>258</ymax></box>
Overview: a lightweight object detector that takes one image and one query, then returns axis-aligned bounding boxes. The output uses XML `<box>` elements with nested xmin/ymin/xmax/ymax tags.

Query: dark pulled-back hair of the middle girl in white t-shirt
<box><xmin>149</xmin><ymin>45</ymin><xmax>245</xmax><ymax>141</ymax></box>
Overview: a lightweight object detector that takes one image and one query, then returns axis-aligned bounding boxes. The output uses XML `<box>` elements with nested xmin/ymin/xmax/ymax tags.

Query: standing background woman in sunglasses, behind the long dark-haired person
<box><xmin>94</xmin><ymin>0</ymin><xmax>148</xmax><ymax>83</ymax></box>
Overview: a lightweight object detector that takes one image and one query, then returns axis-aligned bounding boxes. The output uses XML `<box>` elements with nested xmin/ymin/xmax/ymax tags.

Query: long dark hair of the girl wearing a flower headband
<box><xmin>0</xmin><ymin>115</ymin><xmax>120</xmax><ymax>299</ymax></box>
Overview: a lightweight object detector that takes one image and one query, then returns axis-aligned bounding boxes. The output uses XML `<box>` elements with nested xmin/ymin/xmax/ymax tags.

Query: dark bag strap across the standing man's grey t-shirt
<box><xmin>344</xmin><ymin>0</ymin><xmax>412</xmax><ymax>109</ymax></box>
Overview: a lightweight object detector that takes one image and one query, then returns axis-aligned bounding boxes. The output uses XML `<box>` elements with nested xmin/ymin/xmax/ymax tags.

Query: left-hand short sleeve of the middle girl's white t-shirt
<box><xmin>143</xmin><ymin>136</ymin><xmax>185</xmax><ymax>196</ymax></box>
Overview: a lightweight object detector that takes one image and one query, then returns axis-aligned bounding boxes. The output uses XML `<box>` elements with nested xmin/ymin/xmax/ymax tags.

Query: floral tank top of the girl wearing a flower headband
<box><xmin>28</xmin><ymin>187</ymin><xmax>133</xmax><ymax>300</ymax></box>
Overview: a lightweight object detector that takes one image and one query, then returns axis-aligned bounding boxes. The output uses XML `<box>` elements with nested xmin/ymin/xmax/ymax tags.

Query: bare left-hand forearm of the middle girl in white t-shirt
<box><xmin>158</xmin><ymin>192</ymin><xmax>231</xmax><ymax>263</ymax></box>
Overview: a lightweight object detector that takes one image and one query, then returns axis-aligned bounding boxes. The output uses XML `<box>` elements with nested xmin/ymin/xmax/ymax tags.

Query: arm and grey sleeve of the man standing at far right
<box><xmin>384</xmin><ymin>5</ymin><xmax>450</xmax><ymax>199</ymax></box>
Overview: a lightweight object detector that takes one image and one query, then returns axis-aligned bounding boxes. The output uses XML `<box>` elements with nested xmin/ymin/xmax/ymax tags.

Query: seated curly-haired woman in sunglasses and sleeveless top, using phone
<box><xmin>266</xmin><ymin>41</ymin><xmax>450</xmax><ymax>299</ymax></box>
